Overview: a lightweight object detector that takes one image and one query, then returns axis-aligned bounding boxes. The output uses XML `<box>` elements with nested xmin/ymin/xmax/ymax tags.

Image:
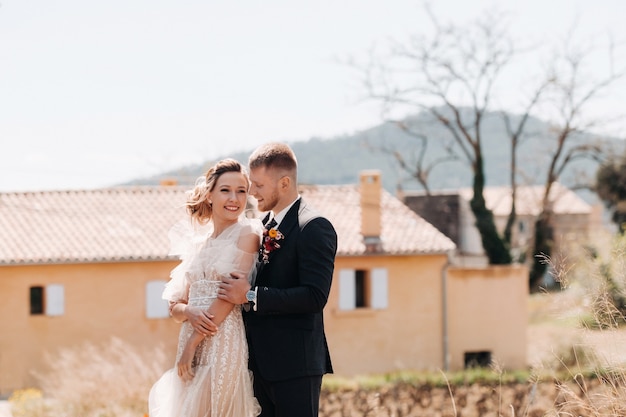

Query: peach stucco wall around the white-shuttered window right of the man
<box><xmin>325</xmin><ymin>255</ymin><xmax>446</xmax><ymax>376</ymax></box>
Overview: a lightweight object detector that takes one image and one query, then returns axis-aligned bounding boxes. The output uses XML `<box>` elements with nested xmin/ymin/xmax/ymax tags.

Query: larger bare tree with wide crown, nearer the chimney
<box><xmin>346</xmin><ymin>7</ymin><xmax>516</xmax><ymax>264</ymax></box>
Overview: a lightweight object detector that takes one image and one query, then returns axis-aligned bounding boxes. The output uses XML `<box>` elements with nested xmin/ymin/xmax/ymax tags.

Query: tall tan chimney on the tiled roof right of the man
<box><xmin>360</xmin><ymin>170</ymin><xmax>382</xmax><ymax>253</ymax></box>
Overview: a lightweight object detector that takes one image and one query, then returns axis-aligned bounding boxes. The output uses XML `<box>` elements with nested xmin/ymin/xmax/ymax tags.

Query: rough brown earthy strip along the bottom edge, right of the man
<box><xmin>319</xmin><ymin>380</ymin><xmax>612</xmax><ymax>417</ymax></box>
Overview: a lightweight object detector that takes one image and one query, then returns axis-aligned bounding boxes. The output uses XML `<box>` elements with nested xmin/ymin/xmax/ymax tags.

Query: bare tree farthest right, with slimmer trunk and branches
<box><xmin>530</xmin><ymin>34</ymin><xmax>626</xmax><ymax>290</ymax></box>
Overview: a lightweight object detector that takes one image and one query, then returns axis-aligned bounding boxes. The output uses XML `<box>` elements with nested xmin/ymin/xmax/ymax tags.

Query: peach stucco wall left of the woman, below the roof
<box><xmin>0</xmin><ymin>262</ymin><xmax>179</xmax><ymax>395</ymax></box>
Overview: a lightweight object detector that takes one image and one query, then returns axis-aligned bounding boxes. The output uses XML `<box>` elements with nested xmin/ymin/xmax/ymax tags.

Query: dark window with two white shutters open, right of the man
<box><xmin>339</xmin><ymin>268</ymin><xmax>388</xmax><ymax>310</ymax></box>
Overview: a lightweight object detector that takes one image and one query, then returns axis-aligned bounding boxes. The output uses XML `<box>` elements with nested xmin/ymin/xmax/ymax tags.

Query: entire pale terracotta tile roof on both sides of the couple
<box><xmin>0</xmin><ymin>185</ymin><xmax>455</xmax><ymax>265</ymax></box>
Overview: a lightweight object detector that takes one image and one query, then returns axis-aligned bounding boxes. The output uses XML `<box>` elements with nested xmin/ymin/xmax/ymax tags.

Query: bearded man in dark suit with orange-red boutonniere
<box><xmin>218</xmin><ymin>143</ymin><xmax>337</xmax><ymax>417</ymax></box>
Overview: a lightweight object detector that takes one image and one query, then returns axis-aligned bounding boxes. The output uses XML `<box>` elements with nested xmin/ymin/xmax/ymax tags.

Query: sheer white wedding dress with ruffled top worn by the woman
<box><xmin>148</xmin><ymin>218</ymin><xmax>262</xmax><ymax>417</ymax></box>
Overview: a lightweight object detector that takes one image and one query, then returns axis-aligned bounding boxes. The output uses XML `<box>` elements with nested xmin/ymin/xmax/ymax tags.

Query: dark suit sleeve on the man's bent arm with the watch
<box><xmin>258</xmin><ymin>217</ymin><xmax>337</xmax><ymax>314</ymax></box>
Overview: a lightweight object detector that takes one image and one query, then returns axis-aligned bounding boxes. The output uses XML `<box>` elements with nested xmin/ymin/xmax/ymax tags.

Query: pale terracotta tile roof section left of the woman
<box><xmin>0</xmin><ymin>187</ymin><xmax>184</xmax><ymax>264</ymax></box>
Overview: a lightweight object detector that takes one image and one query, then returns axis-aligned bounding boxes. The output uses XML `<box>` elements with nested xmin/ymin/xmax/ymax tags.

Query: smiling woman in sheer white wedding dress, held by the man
<box><xmin>148</xmin><ymin>159</ymin><xmax>262</xmax><ymax>417</ymax></box>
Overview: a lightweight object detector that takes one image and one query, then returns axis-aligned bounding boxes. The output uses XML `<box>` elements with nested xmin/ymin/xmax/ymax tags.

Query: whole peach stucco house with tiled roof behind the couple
<box><xmin>0</xmin><ymin>171</ymin><xmax>527</xmax><ymax>395</ymax></box>
